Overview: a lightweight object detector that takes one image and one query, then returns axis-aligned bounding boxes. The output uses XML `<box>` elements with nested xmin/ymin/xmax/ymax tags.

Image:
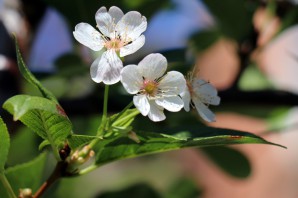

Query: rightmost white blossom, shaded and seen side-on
<box><xmin>181</xmin><ymin>78</ymin><xmax>220</xmax><ymax>122</ymax></box>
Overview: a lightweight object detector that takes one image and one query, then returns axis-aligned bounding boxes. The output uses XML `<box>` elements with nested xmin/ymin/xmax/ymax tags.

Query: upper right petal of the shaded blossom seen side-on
<box><xmin>192</xmin><ymin>79</ymin><xmax>220</xmax><ymax>105</ymax></box>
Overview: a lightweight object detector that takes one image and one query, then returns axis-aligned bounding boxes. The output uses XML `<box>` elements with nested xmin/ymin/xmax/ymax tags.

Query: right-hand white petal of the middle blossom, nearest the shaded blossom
<box><xmin>159</xmin><ymin>71</ymin><xmax>186</xmax><ymax>96</ymax></box>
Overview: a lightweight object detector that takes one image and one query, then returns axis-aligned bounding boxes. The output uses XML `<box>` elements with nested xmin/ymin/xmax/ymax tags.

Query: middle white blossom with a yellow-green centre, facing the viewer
<box><xmin>121</xmin><ymin>54</ymin><xmax>186</xmax><ymax>122</ymax></box>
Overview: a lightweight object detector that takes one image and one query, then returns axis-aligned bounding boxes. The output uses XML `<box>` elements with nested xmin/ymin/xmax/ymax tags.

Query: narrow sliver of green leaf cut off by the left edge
<box><xmin>0</xmin><ymin>117</ymin><xmax>10</xmax><ymax>174</ymax></box>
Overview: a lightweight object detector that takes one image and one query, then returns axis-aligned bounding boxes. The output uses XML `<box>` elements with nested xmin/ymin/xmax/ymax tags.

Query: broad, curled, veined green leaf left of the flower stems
<box><xmin>3</xmin><ymin>95</ymin><xmax>72</xmax><ymax>153</ymax></box>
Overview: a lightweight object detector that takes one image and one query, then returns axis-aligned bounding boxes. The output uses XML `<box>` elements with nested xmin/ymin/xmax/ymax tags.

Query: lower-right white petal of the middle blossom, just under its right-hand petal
<box><xmin>155</xmin><ymin>96</ymin><xmax>184</xmax><ymax>112</ymax></box>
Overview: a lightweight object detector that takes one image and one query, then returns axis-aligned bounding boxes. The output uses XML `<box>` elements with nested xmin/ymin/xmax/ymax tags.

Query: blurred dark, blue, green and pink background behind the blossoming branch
<box><xmin>0</xmin><ymin>0</ymin><xmax>298</xmax><ymax>198</ymax></box>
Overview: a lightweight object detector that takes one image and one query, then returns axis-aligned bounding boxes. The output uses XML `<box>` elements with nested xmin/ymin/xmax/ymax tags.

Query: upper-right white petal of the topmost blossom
<box><xmin>116</xmin><ymin>11</ymin><xmax>147</xmax><ymax>41</ymax></box>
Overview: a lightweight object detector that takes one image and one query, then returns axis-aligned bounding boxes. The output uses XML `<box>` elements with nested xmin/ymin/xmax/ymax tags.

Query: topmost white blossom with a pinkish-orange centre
<box><xmin>73</xmin><ymin>6</ymin><xmax>147</xmax><ymax>84</ymax></box>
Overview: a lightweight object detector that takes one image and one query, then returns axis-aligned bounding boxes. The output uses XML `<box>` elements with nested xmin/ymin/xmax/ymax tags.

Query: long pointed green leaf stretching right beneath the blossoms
<box><xmin>94</xmin><ymin>127</ymin><xmax>283</xmax><ymax>165</ymax></box>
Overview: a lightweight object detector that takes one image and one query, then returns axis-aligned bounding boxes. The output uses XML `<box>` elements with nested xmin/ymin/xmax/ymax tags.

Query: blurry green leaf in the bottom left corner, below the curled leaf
<box><xmin>0</xmin><ymin>153</ymin><xmax>47</xmax><ymax>194</ymax></box>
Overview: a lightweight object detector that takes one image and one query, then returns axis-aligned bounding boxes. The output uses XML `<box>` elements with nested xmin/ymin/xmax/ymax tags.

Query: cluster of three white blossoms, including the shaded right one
<box><xmin>73</xmin><ymin>6</ymin><xmax>220</xmax><ymax>122</ymax></box>
